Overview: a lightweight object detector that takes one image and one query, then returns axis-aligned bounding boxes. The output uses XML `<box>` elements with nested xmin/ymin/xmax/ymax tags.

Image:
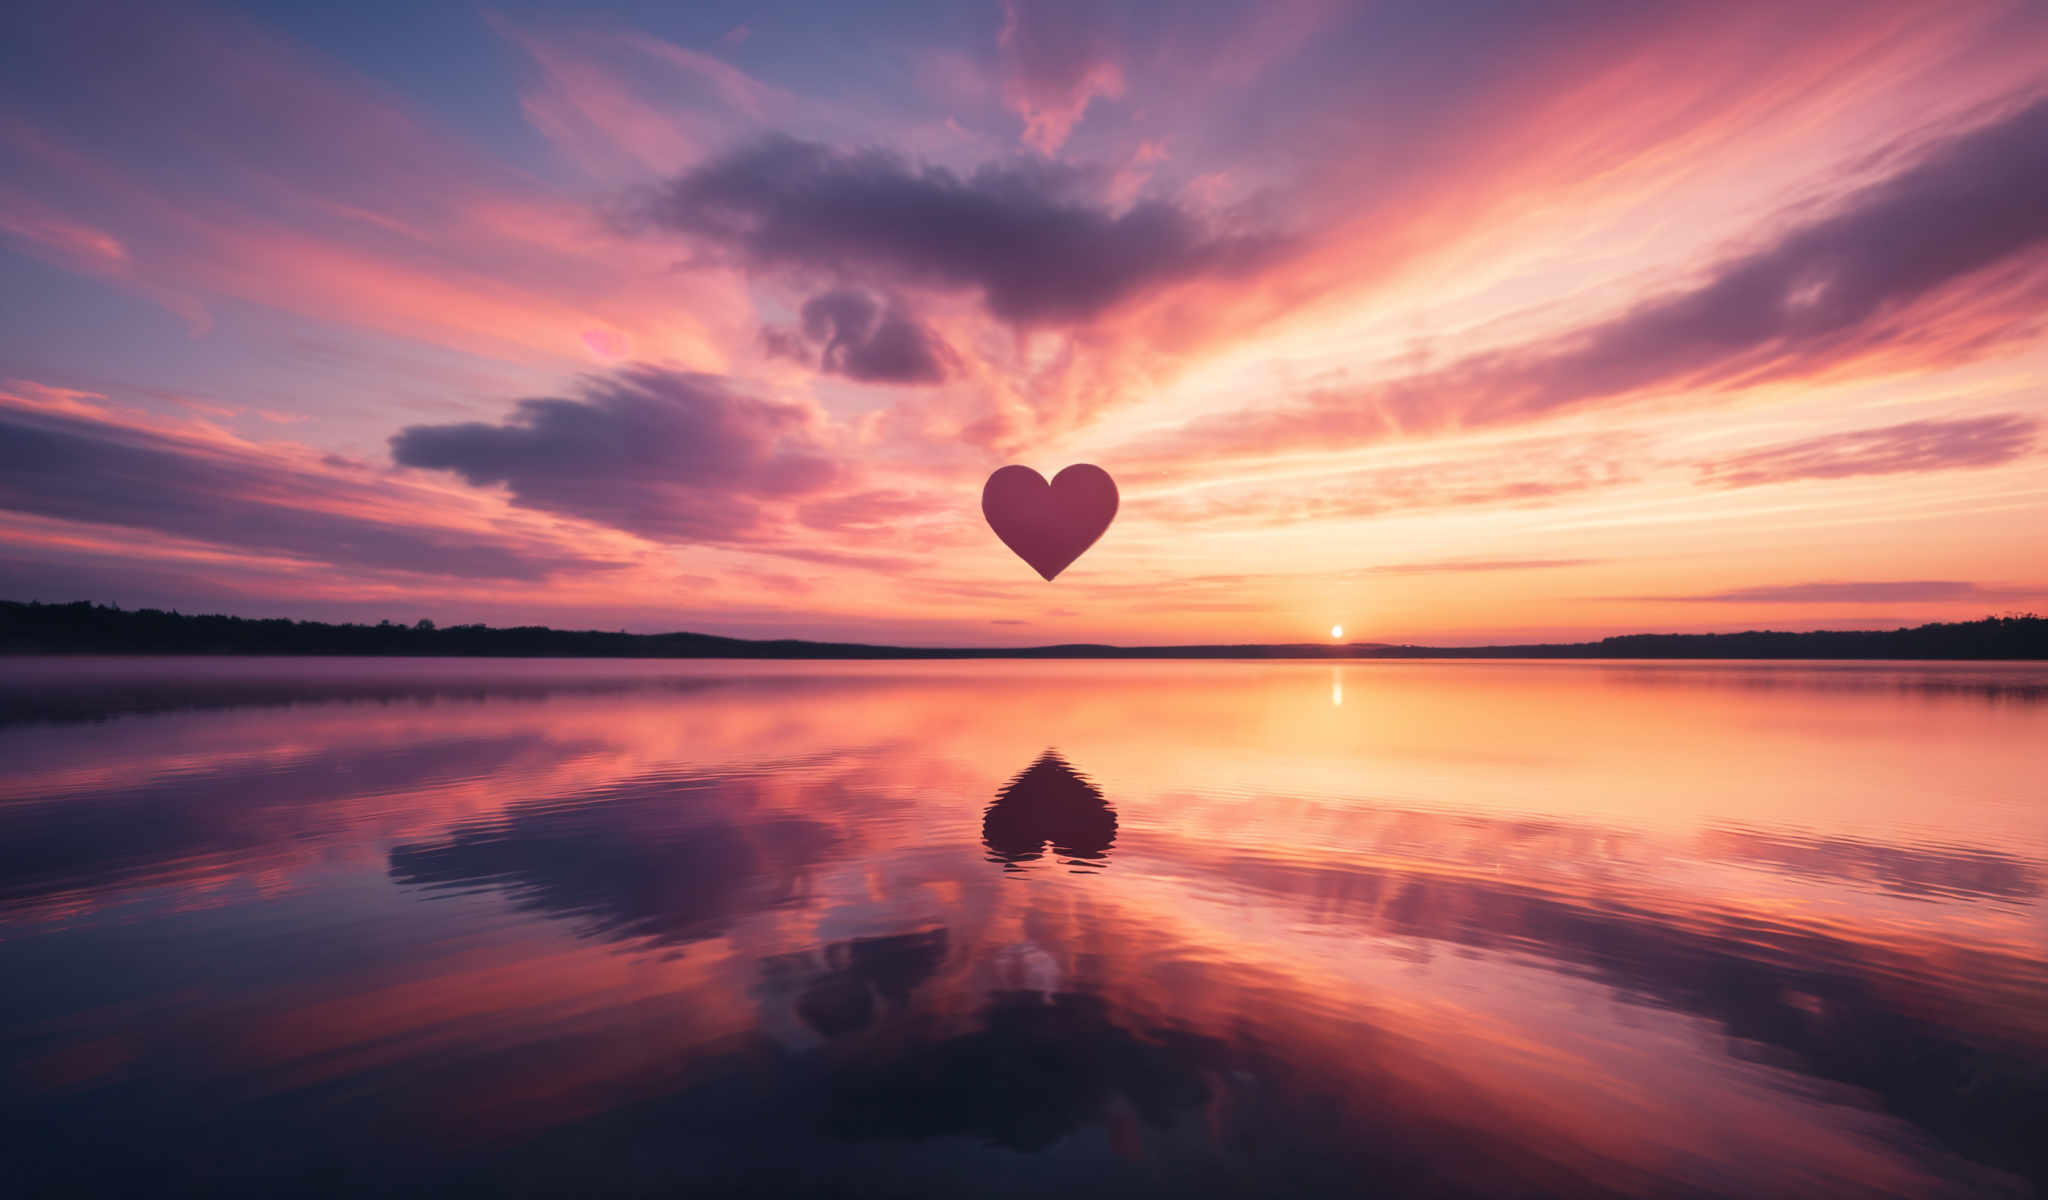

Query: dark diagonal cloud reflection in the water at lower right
<box><xmin>1219</xmin><ymin>858</ymin><xmax>2048</xmax><ymax>1180</ymax></box>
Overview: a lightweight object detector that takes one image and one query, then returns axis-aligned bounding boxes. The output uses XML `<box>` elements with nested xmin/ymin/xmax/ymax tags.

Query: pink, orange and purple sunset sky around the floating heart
<box><xmin>0</xmin><ymin>0</ymin><xmax>2048</xmax><ymax>645</ymax></box>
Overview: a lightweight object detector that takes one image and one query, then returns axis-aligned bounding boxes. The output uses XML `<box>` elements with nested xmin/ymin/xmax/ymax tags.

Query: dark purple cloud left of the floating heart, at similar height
<box><xmin>391</xmin><ymin>367</ymin><xmax>840</xmax><ymax>543</ymax></box>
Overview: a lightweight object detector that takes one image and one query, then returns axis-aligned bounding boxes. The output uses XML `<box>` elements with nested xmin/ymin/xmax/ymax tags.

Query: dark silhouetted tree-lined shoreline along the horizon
<box><xmin>0</xmin><ymin>600</ymin><xmax>2048</xmax><ymax>661</ymax></box>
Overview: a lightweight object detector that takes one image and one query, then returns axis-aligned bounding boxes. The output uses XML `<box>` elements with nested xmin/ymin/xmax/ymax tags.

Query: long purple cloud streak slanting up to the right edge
<box><xmin>1153</xmin><ymin>100</ymin><xmax>2048</xmax><ymax>455</ymax></box>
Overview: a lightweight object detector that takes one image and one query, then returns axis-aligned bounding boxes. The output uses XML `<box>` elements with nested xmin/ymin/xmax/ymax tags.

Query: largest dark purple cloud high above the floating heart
<box><xmin>631</xmin><ymin>137</ymin><xmax>1282</xmax><ymax>326</ymax></box>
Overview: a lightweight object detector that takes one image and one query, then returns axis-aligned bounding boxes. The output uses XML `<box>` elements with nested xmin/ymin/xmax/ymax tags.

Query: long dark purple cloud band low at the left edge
<box><xmin>0</xmin><ymin>401</ymin><xmax>608</xmax><ymax>580</ymax></box>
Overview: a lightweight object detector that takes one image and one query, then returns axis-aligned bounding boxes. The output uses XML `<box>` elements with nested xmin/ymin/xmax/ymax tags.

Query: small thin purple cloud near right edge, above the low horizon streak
<box><xmin>1700</xmin><ymin>412</ymin><xmax>2040</xmax><ymax>487</ymax></box>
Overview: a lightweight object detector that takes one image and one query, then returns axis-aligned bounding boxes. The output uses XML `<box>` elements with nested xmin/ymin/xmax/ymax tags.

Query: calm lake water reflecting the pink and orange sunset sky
<box><xmin>0</xmin><ymin>659</ymin><xmax>2048</xmax><ymax>1196</ymax></box>
